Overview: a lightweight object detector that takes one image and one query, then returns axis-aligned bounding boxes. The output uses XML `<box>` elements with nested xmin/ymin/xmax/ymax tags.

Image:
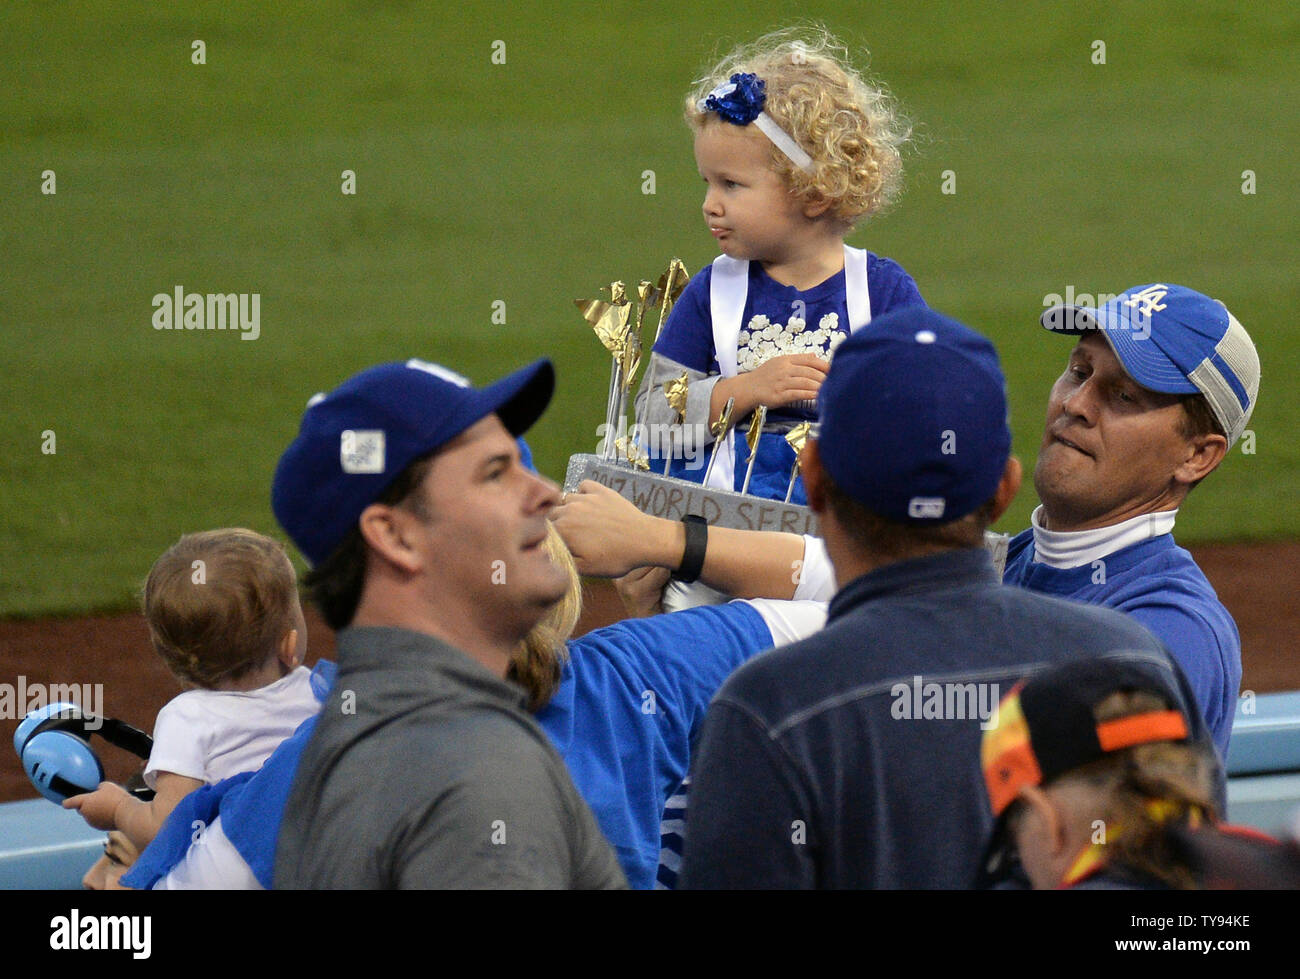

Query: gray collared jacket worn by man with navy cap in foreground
<box><xmin>274</xmin><ymin>628</ymin><xmax>627</xmax><ymax>889</ymax></box>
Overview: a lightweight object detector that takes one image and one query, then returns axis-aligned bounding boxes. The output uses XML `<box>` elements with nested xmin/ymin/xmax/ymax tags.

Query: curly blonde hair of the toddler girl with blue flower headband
<box><xmin>685</xmin><ymin>27</ymin><xmax>911</xmax><ymax>228</ymax></box>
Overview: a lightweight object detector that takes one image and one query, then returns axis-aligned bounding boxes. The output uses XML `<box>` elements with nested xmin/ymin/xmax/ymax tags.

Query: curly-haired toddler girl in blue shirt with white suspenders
<box><xmin>638</xmin><ymin>31</ymin><xmax>923</xmax><ymax>504</ymax></box>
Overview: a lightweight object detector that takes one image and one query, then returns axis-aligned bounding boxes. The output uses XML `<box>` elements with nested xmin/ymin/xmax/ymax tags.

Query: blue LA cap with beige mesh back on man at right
<box><xmin>1041</xmin><ymin>282</ymin><xmax>1260</xmax><ymax>449</ymax></box>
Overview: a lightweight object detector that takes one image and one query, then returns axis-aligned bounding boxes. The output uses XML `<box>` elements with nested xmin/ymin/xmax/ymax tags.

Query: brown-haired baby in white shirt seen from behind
<box><xmin>64</xmin><ymin>528</ymin><xmax>320</xmax><ymax>849</ymax></box>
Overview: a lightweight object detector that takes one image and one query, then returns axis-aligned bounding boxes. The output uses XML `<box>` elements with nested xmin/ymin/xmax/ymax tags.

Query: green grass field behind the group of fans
<box><xmin>0</xmin><ymin>0</ymin><xmax>1300</xmax><ymax>615</ymax></box>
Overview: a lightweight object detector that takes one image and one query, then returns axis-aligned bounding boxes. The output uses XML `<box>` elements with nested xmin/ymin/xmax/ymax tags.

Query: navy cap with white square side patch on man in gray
<box><xmin>270</xmin><ymin>358</ymin><xmax>555</xmax><ymax>564</ymax></box>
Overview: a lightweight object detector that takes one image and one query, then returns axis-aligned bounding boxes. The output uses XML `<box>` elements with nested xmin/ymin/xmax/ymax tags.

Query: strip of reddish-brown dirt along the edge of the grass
<box><xmin>0</xmin><ymin>541</ymin><xmax>1300</xmax><ymax>802</ymax></box>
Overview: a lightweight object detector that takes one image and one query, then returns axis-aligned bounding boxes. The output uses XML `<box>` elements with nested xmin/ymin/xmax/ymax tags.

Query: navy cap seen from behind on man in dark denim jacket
<box><xmin>818</xmin><ymin>306</ymin><xmax>1011</xmax><ymax>525</ymax></box>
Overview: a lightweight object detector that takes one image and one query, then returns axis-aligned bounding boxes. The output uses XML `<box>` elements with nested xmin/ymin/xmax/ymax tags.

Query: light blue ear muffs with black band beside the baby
<box><xmin>13</xmin><ymin>702</ymin><xmax>153</xmax><ymax>805</ymax></box>
